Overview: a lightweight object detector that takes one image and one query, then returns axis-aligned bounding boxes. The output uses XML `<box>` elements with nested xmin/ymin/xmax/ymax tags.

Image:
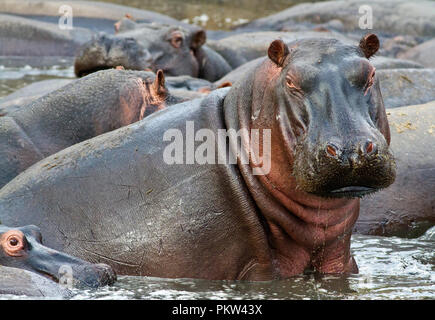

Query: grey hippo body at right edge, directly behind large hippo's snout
<box><xmin>355</xmin><ymin>101</ymin><xmax>435</xmax><ymax>237</ymax></box>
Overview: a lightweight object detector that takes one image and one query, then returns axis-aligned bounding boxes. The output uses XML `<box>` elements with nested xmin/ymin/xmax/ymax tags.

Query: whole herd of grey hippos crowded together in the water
<box><xmin>0</xmin><ymin>0</ymin><xmax>435</xmax><ymax>296</ymax></box>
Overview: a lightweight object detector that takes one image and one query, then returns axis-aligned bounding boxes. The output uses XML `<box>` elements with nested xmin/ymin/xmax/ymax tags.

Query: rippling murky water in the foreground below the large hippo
<box><xmin>0</xmin><ymin>227</ymin><xmax>435</xmax><ymax>300</ymax></box>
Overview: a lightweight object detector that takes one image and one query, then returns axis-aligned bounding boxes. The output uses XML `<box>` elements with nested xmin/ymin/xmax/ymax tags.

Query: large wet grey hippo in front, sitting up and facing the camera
<box><xmin>0</xmin><ymin>34</ymin><xmax>395</xmax><ymax>280</ymax></box>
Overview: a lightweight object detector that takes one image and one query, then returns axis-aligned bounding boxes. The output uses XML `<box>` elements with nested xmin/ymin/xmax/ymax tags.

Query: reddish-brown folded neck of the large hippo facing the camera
<box><xmin>224</xmin><ymin>61</ymin><xmax>359</xmax><ymax>277</ymax></box>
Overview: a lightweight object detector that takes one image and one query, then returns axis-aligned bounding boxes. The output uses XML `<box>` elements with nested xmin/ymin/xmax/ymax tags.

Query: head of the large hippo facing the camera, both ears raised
<box><xmin>249</xmin><ymin>34</ymin><xmax>396</xmax><ymax>198</ymax></box>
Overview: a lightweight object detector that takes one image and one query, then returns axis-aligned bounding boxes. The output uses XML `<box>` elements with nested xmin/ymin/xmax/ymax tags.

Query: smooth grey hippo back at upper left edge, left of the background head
<box><xmin>0</xmin><ymin>14</ymin><xmax>92</xmax><ymax>57</ymax></box>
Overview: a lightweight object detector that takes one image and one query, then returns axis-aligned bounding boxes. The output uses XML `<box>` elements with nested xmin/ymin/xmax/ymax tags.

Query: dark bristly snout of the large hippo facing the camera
<box><xmin>294</xmin><ymin>138</ymin><xmax>396</xmax><ymax>198</ymax></box>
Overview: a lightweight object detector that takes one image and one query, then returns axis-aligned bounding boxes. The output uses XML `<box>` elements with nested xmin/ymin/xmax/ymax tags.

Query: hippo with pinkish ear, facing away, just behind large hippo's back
<box><xmin>0</xmin><ymin>70</ymin><xmax>186</xmax><ymax>187</ymax></box>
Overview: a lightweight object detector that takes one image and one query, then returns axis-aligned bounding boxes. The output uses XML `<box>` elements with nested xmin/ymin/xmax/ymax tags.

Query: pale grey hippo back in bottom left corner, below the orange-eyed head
<box><xmin>0</xmin><ymin>265</ymin><xmax>71</xmax><ymax>299</ymax></box>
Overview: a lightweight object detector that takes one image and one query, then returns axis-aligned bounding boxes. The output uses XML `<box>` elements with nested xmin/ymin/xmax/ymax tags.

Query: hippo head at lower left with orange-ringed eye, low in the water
<box><xmin>0</xmin><ymin>225</ymin><xmax>116</xmax><ymax>288</ymax></box>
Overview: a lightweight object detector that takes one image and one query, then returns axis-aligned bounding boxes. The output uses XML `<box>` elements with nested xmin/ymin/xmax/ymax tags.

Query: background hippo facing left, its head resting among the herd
<box><xmin>74</xmin><ymin>19</ymin><xmax>231</xmax><ymax>81</ymax></box>
